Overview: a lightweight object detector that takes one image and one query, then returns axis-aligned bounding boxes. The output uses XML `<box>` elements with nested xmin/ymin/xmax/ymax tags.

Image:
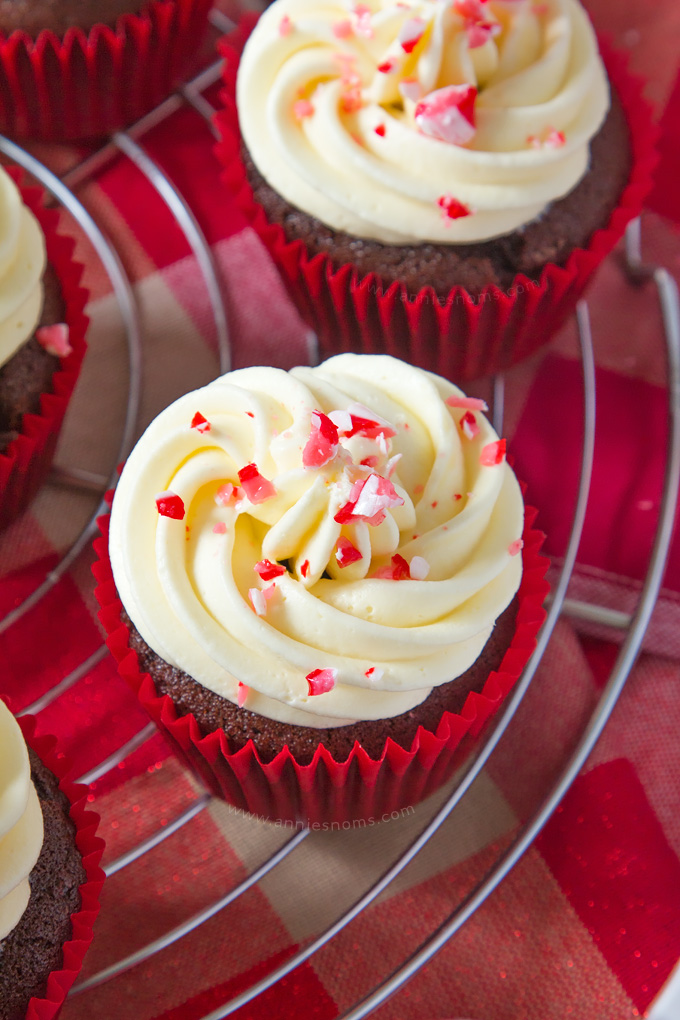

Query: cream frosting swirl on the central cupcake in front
<box><xmin>110</xmin><ymin>354</ymin><xmax>523</xmax><ymax>726</ymax></box>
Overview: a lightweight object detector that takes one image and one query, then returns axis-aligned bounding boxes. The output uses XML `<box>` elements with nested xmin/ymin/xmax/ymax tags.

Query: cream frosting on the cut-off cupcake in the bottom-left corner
<box><xmin>0</xmin><ymin>702</ymin><xmax>43</xmax><ymax>939</ymax></box>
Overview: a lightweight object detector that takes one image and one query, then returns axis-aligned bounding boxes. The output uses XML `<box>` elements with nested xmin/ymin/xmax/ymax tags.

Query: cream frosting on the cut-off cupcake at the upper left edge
<box><xmin>0</xmin><ymin>168</ymin><xmax>46</xmax><ymax>365</ymax></box>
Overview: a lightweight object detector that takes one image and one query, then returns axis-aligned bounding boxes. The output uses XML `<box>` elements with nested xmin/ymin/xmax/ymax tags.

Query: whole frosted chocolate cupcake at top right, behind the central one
<box><xmin>218</xmin><ymin>0</ymin><xmax>651</xmax><ymax>378</ymax></box>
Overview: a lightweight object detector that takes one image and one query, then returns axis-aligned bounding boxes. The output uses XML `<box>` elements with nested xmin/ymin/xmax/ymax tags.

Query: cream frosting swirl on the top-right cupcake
<box><xmin>238</xmin><ymin>0</ymin><xmax>609</xmax><ymax>244</ymax></box>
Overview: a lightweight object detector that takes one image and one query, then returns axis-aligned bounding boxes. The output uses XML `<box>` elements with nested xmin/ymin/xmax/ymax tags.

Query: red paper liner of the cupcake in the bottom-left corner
<box><xmin>4</xmin><ymin>715</ymin><xmax>104</xmax><ymax>1020</ymax></box>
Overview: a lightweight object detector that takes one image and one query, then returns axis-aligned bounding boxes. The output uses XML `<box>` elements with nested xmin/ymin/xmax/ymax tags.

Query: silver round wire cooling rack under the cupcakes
<box><xmin>0</xmin><ymin>11</ymin><xmax>680</xmax><ymax>1020</ymax></box>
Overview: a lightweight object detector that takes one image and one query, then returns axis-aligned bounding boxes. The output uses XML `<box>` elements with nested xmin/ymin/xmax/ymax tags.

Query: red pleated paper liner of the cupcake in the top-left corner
<box><xmin>0</xmin><ymin>0</ymin><xmax>212</xmax><ymax>142</ymax></box>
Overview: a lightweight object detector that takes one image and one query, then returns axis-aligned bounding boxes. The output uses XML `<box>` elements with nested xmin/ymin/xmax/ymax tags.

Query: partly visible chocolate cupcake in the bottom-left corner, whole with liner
<box><xmin>0</xmin><ymin>702</ymin><xmax>103</xmax><ymax>1020</ymax></box>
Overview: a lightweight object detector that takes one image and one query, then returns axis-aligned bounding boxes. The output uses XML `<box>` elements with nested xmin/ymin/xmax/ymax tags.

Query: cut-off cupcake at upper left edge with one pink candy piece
<box><xmin>0</xmin><ymin>168</ymin><xmax>88</xmax><ymax>528</ymax></box>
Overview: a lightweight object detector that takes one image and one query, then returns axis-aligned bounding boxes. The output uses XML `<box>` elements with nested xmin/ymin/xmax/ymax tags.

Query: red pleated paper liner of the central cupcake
<box><xmin>93</xmin><ymin>507</ymin><xmax>550</xmax><ymax>828</ymax></box>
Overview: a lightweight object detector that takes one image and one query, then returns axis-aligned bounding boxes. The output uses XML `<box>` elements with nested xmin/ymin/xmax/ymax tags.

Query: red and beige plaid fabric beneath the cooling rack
<box><xmin>0</xmin><ymin>0</ymin><xmax>680</xmax><ymax>1020</ymax></box>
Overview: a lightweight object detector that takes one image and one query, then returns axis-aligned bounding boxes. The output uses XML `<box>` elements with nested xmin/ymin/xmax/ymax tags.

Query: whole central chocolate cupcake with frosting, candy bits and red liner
<box><xmin>96</xmin><ymin>354</ymin><xmax>545</xmax><ymax>824</ymax></box>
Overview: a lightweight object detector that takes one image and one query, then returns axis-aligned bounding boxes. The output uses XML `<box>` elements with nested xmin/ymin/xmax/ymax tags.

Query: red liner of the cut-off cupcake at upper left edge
<box><xmin>0</xmin><ymin>167</ymin><xmax>89</xmax><ymax>529</ymax></box>
